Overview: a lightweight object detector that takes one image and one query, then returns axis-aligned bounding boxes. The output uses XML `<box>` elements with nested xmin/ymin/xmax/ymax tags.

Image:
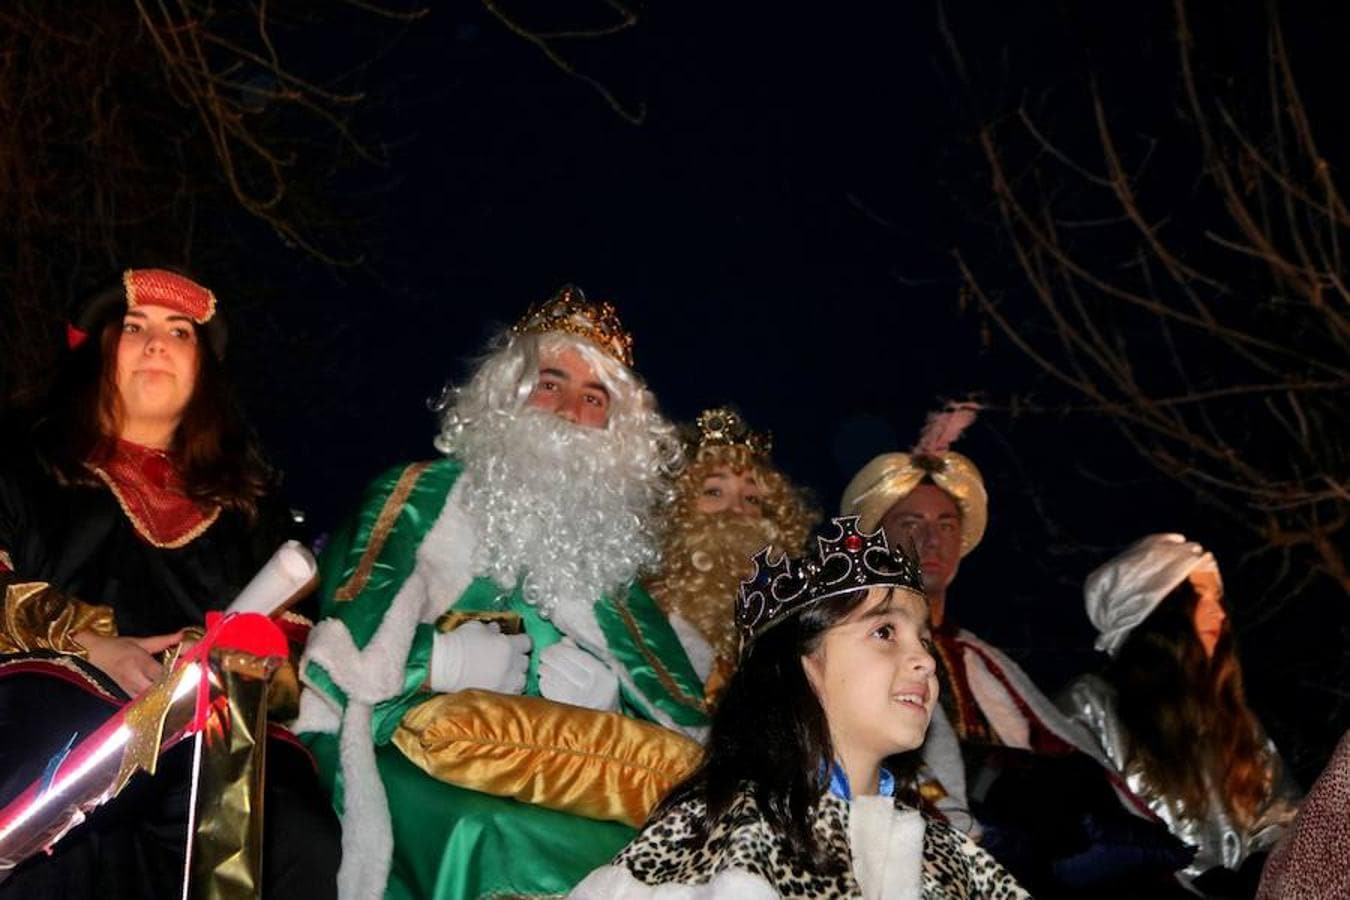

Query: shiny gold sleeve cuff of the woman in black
<box><xmin>0</xmin><ymin>582</ymin><xmax>117</xmax><ymax>657</ymax></box>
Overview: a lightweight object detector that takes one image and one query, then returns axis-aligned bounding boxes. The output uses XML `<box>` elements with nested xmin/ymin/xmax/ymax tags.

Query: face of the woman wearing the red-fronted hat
<box><xmin>117</xmin><ymin>306</ymin><xmax>200</xmax><ymax>433</ymax></box>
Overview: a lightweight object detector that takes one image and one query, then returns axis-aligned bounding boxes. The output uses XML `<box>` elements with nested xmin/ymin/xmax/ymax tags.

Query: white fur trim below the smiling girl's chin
<box><xmin>848</xmin><ymin>796</ymin><xmax>923</xmax><ymax>900</ymax></box>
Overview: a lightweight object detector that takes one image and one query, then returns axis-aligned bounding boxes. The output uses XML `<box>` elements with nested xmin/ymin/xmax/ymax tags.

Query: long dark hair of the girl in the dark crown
<box><xmin>652</xmin><ymin>590</ymin><xmax>917</xmax><ymax>874</ymax></box>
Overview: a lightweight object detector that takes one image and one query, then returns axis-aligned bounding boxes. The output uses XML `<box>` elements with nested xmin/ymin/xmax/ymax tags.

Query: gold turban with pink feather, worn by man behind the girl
<box><xmin>840</xmin><ymin>451</ymin><xmax>990</xmax><ymax>556</ymax></box>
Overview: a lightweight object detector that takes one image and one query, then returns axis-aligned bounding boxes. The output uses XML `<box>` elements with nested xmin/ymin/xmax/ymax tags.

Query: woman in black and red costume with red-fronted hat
<box><xmin>0</xmin><ymin>269</ymin><xmax>339</xmax><ymax>899</ymax></box>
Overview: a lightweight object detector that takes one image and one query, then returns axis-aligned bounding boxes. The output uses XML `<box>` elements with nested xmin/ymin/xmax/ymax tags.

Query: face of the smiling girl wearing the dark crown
<box><xmin>802</xmin><ymin>587</ymin><xmax>938</xmax><ymax>765</ymax></box>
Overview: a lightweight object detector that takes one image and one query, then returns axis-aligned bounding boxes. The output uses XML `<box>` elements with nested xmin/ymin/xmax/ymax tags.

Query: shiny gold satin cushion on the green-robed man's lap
<box><xmin>394</xmin><ymin>691</ymin><xmax>703</xmax><ymax>827</ymax></box>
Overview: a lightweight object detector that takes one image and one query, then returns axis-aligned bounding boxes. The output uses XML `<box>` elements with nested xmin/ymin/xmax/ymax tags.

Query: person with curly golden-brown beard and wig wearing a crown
<box><xmin>647</xmin><ymin>406</ymin><xmax>817</xmax><ymax>699</ymax></box>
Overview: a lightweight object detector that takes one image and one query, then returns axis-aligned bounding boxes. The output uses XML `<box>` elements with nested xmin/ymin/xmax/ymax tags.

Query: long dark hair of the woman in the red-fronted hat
<box><xmin>34</xmin><ymin>295</ymin><xmax>277</xmax><ymax>518</ymax></box>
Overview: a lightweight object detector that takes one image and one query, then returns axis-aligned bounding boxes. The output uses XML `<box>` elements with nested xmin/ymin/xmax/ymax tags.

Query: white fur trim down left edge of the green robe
<box><xmin>300</xmin><ymin>484</ymin><xmax>475</xmax><ymax>900</ymax></box>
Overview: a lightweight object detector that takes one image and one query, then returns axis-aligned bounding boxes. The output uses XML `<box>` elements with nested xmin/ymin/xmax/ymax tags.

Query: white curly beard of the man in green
<box><xmin>458</xmin><ymin>409</ymin><xmax>666</xmax><ymax>625</ymax></box>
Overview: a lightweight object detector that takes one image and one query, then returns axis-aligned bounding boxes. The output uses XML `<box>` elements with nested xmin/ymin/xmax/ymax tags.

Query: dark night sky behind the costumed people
<box><xmin>205</xmin><ymin>3</ymin><xmax>1346</xmax><ymax>775</ymax></box>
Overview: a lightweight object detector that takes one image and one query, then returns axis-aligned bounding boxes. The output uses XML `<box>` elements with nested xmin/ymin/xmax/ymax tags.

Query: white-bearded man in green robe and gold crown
<box><xmin>296</xmin><ymin>287</ymin><xmax>706</xmax><ymax>900</ymax></box>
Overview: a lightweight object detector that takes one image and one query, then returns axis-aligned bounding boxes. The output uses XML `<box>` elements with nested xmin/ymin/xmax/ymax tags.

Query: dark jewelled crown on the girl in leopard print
<box><xmin>736</xmin><ymin>515</ymin><xmax>923</xmax><ymax>649</ymax></box>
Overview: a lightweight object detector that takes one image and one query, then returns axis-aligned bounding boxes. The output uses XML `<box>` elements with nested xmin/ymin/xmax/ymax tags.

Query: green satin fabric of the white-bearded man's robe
<box><xmin>305</xmin><ymin>460</ymin><xmax>706</xmax><ymax>900</ymax></box>
